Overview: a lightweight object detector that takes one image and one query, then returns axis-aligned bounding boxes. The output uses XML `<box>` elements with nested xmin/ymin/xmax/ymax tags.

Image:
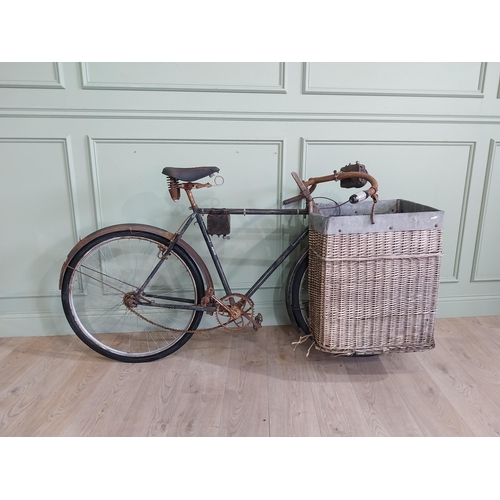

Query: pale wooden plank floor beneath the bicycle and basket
<box><xmin>0</xmin><ymin>316</ymin><xmax>500</xmax><ymax>436</ymax></box>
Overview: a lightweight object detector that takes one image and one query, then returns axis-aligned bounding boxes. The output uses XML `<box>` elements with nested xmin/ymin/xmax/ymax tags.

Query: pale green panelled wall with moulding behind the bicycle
<box><xmin>0</xmin><ymin>62</ymin><xmax>500</xmax><ymax>336</ymax></box>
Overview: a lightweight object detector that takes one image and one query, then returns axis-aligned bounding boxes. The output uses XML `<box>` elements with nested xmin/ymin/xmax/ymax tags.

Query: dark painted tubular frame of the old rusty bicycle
<box><xmin>137</xmin><ymin>206</ymin><xmax>309</xmax><ymax>312</ymax></box>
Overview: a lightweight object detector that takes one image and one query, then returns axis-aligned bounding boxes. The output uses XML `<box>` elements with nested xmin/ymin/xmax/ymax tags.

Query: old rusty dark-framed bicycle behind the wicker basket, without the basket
<box><xmin>59</xmin><ymin>162</ymin><xmax>378</xmax><ymax>362</ymax></box>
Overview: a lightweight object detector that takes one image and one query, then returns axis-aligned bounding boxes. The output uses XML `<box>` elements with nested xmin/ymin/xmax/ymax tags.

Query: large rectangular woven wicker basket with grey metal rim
<box><xmin>309</xmin><ymin>200</ymin><xmax>444</xmax><ymax>355</ymax></box>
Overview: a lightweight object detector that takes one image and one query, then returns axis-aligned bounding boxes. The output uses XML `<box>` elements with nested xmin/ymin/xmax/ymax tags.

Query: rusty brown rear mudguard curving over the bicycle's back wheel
<box><xmin>59</xmin><ymin>224</ymin><xmax>214</xmax><ymax>290</ymax></box>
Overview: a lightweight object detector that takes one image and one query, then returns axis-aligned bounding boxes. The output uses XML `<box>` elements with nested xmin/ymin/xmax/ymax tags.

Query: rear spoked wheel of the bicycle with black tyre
<box><xmin>61</xmin><ymin>230</ymin><xmax>204</xmax><ymax>363</ymax></box>
